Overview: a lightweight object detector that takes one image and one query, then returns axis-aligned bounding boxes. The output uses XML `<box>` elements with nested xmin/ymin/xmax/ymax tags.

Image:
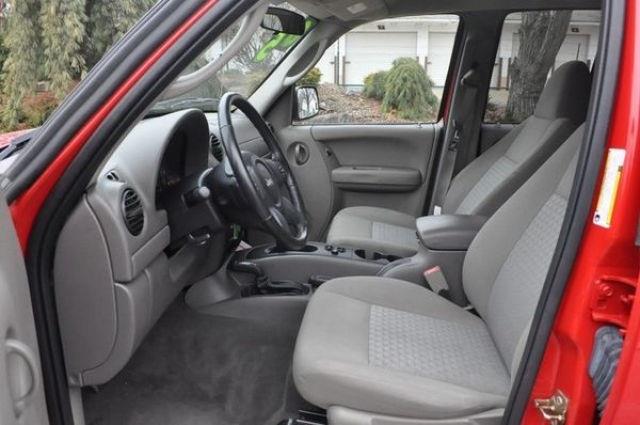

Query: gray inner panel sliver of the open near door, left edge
<box><xmin>0</xmin><ymin>195</ymin><xmax>49</xmax><ymax>425</ymax></box>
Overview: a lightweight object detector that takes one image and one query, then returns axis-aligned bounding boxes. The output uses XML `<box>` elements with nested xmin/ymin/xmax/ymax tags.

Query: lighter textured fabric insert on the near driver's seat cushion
<box><xmin>369</xmin><ymin>305</ymin><xmax>510</xmax><ymax>395</ymax></box>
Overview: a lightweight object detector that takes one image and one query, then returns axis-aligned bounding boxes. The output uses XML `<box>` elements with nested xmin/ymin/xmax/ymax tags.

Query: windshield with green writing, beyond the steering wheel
<box><xmin>150</xmin><ymin>3</ymin><xmax>316</xmax><ymax>115</ymax></box>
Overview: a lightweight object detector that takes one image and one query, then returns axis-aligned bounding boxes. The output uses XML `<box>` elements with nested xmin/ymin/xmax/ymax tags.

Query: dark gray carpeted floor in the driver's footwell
<box><xmin>83</xmin><ymin>294</ymin><xmax>309</xmax><ymax>425</ymax></box>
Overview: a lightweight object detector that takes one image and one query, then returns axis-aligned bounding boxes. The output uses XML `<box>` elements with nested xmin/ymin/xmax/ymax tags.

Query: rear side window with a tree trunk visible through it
<box><xmin>484</xmin><ymin>10</ymin><xmax>600</xmax><ymax>124</ymax></box>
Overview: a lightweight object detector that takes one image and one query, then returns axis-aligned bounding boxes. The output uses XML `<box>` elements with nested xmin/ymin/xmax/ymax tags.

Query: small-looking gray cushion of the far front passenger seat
<box><xmin>327</xmin><ymin>207</ymin><xmax>418</xmax><ymax>257</ymax></box>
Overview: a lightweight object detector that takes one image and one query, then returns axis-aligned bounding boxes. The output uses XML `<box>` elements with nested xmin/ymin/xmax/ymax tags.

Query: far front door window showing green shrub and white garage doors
<box><xmin>297</xmin><ymin>15</ymin><xmax>459</xmax><ymax>125</ymax></box>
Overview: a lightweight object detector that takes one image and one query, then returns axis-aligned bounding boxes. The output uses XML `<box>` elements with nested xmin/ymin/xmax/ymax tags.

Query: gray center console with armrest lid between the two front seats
<box><xmin>222</xmin><ymin>215</ymin><xmax>487</xmax><ymax>306</ymax></box>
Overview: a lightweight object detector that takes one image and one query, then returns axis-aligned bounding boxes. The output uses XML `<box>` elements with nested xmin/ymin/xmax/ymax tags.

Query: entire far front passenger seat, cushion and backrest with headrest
<box><xmin>327</xmin><ymin>61</ymin><xmax>591</xmax><ymax>256</ymax></box>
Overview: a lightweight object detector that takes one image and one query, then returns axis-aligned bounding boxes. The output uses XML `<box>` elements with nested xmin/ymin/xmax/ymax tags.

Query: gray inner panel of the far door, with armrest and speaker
<box><xmin>279</xmin><ymin>124</ymin><xmax>440</xmax><ymax>240</ymax></box>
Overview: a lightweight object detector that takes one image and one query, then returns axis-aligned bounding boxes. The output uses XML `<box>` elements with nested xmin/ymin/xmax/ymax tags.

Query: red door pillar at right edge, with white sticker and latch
<box><xmin>523</xmin><ymin>0</ymin><xmax>640</xmax><ymax>425</ymax></box>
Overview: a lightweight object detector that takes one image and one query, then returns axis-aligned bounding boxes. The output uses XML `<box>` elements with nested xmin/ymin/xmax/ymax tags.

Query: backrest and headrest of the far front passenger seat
<box><xmin>442</xmin><ymin>61</ymin><xmax>591</xmax><ymax>216</ymax></box>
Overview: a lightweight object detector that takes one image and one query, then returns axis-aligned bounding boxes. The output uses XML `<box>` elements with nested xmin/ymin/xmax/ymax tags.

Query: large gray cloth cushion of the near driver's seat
<box><xmin>293</xmin><ymin>277</ymin><xmax>510</xmax><ymax>419</ymax></box>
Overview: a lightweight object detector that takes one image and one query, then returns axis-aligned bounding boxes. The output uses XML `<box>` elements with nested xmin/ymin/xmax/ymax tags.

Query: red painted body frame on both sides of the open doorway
<box><xmin>5</xmin><ymin>0</ymin><xmax>640</xmax><ymax>424</ymax></box>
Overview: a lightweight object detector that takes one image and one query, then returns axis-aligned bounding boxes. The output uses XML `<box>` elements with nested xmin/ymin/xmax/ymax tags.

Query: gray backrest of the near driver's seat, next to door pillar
<box><xmin>463</xmin><ymin>126</ymin><xmax>584</xmax><ymax>374</ymax></box>
